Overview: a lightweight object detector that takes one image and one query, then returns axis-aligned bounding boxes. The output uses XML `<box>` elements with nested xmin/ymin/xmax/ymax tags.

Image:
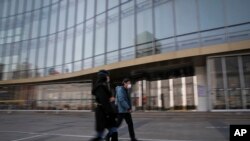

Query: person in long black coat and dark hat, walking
<box><xmin>91</xmin><ymin>70</ymin><xmax>118</xmax><ymax>141</ymax></box>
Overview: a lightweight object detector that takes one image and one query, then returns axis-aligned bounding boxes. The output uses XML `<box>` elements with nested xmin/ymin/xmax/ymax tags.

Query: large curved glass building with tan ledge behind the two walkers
<box><xmin>0</xmin><ymin>0</ymin><xmax>250</xmax><ymax>112</ymax></box>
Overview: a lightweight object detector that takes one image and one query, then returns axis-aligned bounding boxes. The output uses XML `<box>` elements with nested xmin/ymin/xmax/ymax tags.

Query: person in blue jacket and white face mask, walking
<box><xmin>116</xmin><ymin>78</ymin><xmax>138</xmax><ymax>141</ymax></box>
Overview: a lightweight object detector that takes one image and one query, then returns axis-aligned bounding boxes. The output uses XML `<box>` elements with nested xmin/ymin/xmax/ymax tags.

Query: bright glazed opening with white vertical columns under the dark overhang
<box><xmin>131</xmin><ymin>76</ymin><xmax>198</xmax><ymax>110</ymax></box>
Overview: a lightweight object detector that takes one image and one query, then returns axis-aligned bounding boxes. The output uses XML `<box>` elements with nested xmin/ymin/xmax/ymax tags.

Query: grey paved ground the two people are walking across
<box><xmin>0</xmin><ymin>112</ymin><xmax>250</xmax><ymax>141</ymax></box>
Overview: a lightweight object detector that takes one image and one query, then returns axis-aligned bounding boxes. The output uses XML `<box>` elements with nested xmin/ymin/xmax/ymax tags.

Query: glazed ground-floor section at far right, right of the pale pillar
<box><xmin>208</xmin><ymin>54</ymin><xmax>250</xmax><ymax>110</ymax></box>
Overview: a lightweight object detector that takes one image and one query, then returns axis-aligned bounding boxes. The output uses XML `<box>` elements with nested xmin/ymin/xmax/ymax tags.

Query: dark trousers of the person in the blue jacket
<box><xmin>117</xmin><ymin>113</ymin><xmax>135</xmax><ymax>139</ymax></box>
